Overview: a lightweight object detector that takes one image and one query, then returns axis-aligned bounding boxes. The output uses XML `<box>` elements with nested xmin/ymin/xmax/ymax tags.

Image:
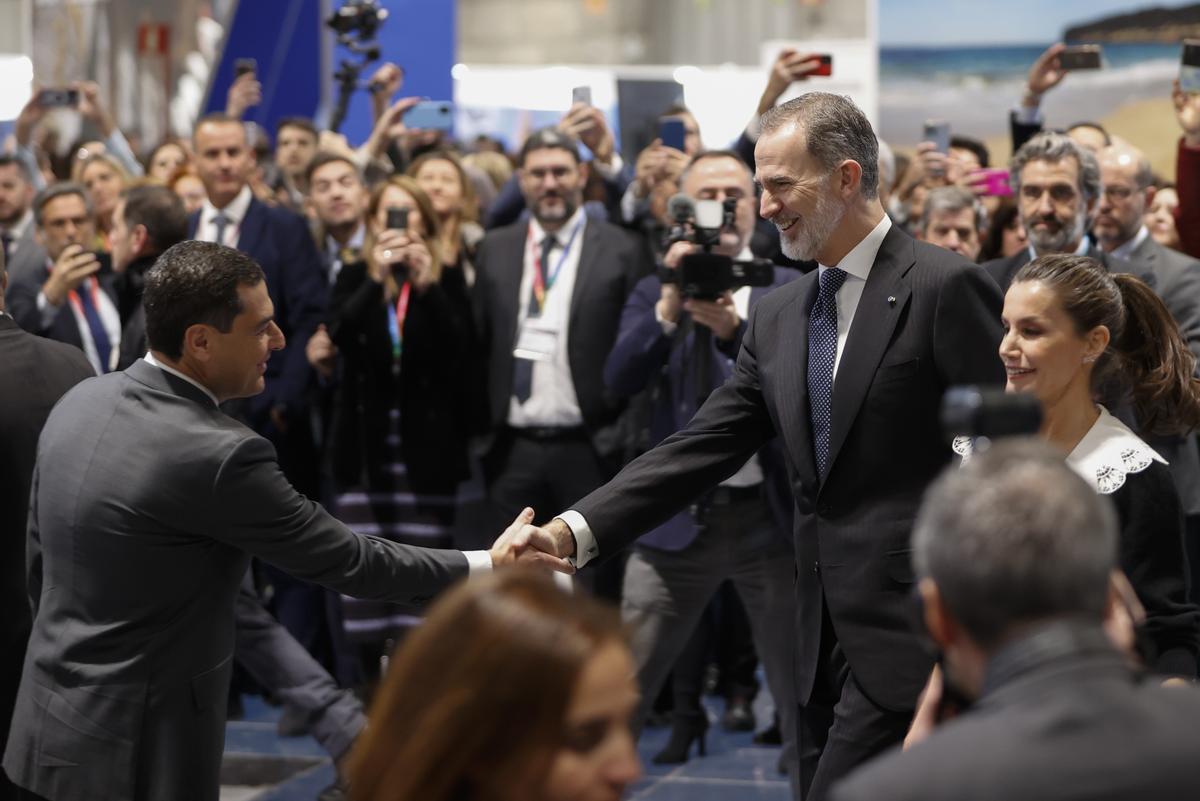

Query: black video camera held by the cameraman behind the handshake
<box><xmin>659</xmin><ymin>193</ymin><xmax>775</xmax><ymax>300</ymax></box>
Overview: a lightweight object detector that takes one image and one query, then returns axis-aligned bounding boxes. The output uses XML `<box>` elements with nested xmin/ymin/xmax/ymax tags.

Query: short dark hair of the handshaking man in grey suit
<box><xmin>143</xmin><ymin>240</ymin><xmax>264</xmax><ymax>359</ymax></box>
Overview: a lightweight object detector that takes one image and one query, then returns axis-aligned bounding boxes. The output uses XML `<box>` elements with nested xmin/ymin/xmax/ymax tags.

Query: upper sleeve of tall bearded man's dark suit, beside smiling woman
<box><xmin>934</xmin><ymin>265</ymin><xmax>1004</xmax><ymax>386</ymax></box>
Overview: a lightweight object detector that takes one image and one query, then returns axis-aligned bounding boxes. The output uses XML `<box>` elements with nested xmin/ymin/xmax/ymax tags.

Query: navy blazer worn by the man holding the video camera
<box><xmin>604</xmin><ymin>267</ymin><xmax>800</xmax><ymax>550</ymax></box>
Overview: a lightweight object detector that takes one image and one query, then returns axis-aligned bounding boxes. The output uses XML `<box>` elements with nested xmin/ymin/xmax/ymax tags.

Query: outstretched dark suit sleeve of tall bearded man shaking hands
<box><xmin>572</xmin><ymin>293</ymin><xmax>775</xmax><ymax>558</ymax></box>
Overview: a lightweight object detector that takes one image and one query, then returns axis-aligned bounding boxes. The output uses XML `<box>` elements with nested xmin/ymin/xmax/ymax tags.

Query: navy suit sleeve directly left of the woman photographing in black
<box><xmin>274</xmin><ymin>213</ymin><xmax>329</xmax><ymax>410</ymax></box>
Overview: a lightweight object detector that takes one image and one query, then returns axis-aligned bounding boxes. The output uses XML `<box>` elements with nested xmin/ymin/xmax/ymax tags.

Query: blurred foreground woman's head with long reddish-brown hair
<box><xmin>349</xmin><ymin>571</ymin><xmax>641</xmax><ymax>801</ymax></box>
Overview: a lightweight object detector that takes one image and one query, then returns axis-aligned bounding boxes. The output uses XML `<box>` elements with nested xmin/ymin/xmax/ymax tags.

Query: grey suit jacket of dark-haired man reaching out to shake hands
<box><xmin>4</xmin><ymin>361</ymin><xmax>468</xmax><ymax>801</ymax></box>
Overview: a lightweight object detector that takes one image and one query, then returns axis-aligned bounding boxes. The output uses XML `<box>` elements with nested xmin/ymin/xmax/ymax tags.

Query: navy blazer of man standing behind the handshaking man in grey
<box><xmin>187</xmin><ymin>198</ymin><xmax>329</xmax><ymax>428</ymax></box>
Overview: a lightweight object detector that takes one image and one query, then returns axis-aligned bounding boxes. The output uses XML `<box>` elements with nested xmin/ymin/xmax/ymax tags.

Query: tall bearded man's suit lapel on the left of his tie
<box><xmin>776</xmin><ymin>275</ymin><xmax>820</xmax><ymax>486</ymax></box>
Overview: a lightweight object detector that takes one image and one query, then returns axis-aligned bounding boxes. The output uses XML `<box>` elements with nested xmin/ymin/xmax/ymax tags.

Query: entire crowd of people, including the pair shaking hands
<box><xmin>0</xmin><ymin>40</ymin><xmax>1200</xmax><ymax>801</ymax></box>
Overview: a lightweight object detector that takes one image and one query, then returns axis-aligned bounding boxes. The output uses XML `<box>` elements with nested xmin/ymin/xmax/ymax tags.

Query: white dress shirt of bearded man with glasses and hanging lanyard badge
<box><xmin>509</xmin><ymin>206</ymin><xmax>587</xmax><ymax>428</ymax></box>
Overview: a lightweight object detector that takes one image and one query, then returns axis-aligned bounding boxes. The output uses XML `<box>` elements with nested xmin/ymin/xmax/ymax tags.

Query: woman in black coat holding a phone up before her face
<box><xmin>318</xmin><ymin>176</ymin><xmax>467</xmax><ymax>679</ymax></box>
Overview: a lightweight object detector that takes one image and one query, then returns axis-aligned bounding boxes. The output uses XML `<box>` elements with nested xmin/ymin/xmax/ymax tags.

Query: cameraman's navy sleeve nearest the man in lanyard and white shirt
<box><xmin>604</xmin><ymin>276</ymin><xmax>672</xmax><ymax>397</ymax></box>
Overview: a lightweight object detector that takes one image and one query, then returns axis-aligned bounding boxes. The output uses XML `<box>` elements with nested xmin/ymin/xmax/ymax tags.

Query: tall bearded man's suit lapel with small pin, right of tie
<box><xmin>825</xmin><ymin>227</ymin><xmax>916</xmax><ymax>475</ymax></box>
